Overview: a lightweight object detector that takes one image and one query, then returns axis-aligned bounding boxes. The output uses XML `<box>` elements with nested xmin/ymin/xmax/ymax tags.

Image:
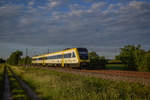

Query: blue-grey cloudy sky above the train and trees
<box><xmin>0</xmin><ymin>0</ymin><xmax>150</xmax><ymax>59</ymax></box>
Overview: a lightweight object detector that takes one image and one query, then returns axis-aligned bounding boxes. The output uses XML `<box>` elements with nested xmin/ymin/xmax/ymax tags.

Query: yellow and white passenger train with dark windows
<box><xmin>32</xmin><ymin>48</ymin><xmax>90</xmax><ymax>68</ymax></box>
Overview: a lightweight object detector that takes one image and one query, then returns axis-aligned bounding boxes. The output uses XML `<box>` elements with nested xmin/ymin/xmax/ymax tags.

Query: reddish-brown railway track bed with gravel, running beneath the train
<box><xmin>33</xmin><ymin>67</ymin><xmax>150</xmax><ymax>86</ymax></box>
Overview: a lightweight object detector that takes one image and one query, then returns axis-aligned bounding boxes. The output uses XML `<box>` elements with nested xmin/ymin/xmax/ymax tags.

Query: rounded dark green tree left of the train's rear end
<box><xmin>7</xmin><ymin>51</ymin><xmax>23</xmax><ymax>65</ymax></box>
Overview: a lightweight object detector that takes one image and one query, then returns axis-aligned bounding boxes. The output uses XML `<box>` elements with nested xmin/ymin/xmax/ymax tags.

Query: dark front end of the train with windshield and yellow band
<box><xmin>77</xmin><ymin>48</ymin><xmax>90</xmax><ymax>68</ymax></box>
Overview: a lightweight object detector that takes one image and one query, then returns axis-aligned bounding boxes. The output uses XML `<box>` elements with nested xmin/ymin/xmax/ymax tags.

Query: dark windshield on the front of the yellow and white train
<box><xmin>77</xmin><ymin>48</ymin><xmax>88</xmax><ymax>60</ymax></box>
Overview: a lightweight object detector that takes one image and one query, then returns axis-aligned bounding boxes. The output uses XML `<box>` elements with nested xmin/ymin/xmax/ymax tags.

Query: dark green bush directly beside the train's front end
<box><xmin>89</xmin><ymin>52</ymin><xmax>107</xmax><ymax>69</ymax></box>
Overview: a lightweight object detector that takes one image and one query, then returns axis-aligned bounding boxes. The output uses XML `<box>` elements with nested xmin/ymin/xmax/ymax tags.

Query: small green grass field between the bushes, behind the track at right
<box><xmin>106</xmin><ymin>64</ymin><xmax>127</xmax><ymax>70</ymax></box>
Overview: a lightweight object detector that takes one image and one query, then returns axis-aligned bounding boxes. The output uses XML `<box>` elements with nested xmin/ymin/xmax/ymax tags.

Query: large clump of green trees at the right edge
<box><xmin>116</xmin><ymin>45</ymin><xmax>150</xmax><ymax>71</ymax></box>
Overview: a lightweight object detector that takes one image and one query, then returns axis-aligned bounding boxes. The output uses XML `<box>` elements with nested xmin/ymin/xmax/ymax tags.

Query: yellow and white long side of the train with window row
<box><xmin>32</xmin><ymin>48</ymin><xmax>89</xmax><ymax>67</ymax></box>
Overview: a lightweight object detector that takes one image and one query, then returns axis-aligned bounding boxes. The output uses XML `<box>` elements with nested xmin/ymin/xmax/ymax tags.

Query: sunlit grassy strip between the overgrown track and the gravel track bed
<box><xmin>11</xmin><ymin>66</ymin><xmax>150</xmax><ymax>100</ymax></box>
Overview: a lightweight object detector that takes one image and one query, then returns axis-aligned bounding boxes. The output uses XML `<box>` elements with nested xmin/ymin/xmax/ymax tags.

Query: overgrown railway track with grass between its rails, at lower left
<box><xmin>2</xmin><ymin>66</ymin><xmax>42</xmax><ymax>100</ymax></box>
